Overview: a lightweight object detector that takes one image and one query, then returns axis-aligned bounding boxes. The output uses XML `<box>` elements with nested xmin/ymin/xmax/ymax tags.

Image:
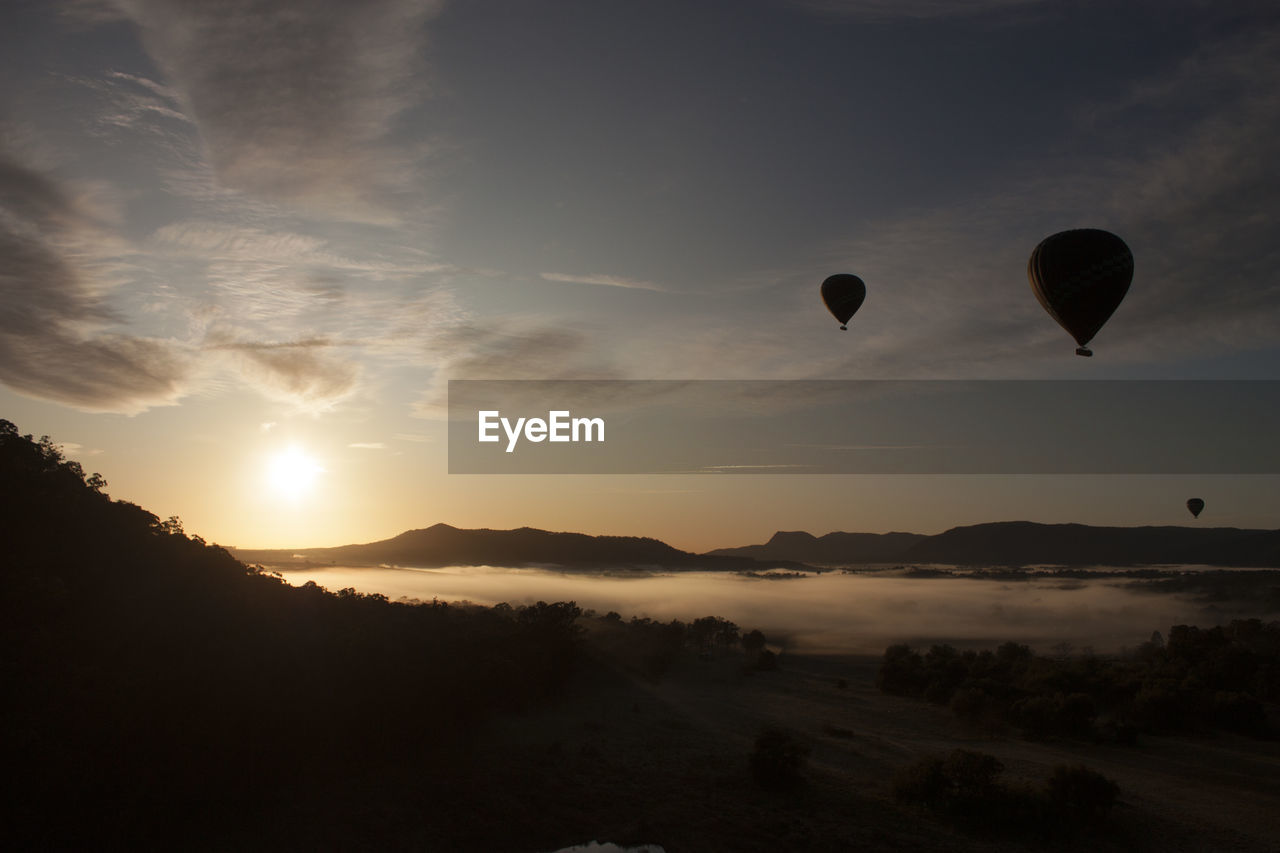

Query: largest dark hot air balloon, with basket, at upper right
<box><xmin>1027</xmin><ymin>228</ymin><xmax>1133</xmax><ymax>356</ymax></box>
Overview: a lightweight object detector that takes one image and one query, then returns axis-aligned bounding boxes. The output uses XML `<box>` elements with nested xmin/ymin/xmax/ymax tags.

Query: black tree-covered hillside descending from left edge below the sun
<box><xmin>0</xmin><ymin>420</ymin><xmax>581</xmax><ymax>849</ymax></box>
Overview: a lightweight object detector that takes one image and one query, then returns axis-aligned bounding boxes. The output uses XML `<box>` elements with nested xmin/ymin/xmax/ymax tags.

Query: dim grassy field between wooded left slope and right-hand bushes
<box><xmin>454</xmin><ymin>652</ymin><xmax>1280</xmax><ymax>853</ymax></box>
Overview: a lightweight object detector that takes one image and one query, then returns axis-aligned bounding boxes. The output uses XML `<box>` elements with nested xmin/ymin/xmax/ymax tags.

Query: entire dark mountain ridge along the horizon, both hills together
<box><xmin>233</xmin><ymin>521</ymin><xmax>1280</xmax><ymax>571</ymax></box>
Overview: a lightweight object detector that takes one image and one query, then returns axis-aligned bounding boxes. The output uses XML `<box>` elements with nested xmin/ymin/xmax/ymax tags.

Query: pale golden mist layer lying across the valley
<box><xmin>272</xmin><ymin>567</ymin><xmax>1275</xmax><ymax>654</ymax></box>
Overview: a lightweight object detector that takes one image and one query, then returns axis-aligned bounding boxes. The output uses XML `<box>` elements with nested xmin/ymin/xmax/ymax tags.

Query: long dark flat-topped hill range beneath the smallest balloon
<box><xmin>710</xmin><ymin>521</ymin><xmax>1280</xmax><ymax>567</ymax></box>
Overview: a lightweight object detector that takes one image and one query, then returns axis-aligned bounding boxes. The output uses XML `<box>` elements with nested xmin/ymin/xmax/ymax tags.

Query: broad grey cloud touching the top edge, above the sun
<box><xmin>116</xmin><ymin>0</ymin><xmax>450</xmax><ymax>222</ymax></box>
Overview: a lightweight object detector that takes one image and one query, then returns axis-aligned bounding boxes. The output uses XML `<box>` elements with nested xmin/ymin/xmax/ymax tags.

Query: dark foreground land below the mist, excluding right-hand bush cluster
<box><xmin>0</xmin><ymin>421</ymin><xmax>1280</xmax><ymax>853</ymax></box>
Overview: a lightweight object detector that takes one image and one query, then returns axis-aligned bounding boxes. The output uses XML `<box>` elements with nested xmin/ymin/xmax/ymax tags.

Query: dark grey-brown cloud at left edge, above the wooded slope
<box><xmin>0</xmin><ymin>155</ymin><xmax>189</xmax><ymax>414</ymax></box>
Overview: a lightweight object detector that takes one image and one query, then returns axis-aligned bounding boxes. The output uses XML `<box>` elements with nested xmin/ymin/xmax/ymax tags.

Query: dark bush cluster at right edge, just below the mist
<box><xmin>877</xmin><ymin>619</ymin><xmax>1280</xmax><ymax>742</ymax></box>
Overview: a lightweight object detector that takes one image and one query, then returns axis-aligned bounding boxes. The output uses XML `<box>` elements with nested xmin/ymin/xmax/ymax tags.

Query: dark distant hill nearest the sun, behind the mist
<box><xmin>234</xmin><ymin>524</ymin><xmax>808</xmax><ymax>571</ymax></box>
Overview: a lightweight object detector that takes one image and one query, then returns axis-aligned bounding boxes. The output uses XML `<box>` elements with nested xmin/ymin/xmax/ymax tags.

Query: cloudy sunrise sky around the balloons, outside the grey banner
<box><xmin>0</xmin><ymin>0</ymin><xmax>1280</xmax><ymax>551</ymax></box>
